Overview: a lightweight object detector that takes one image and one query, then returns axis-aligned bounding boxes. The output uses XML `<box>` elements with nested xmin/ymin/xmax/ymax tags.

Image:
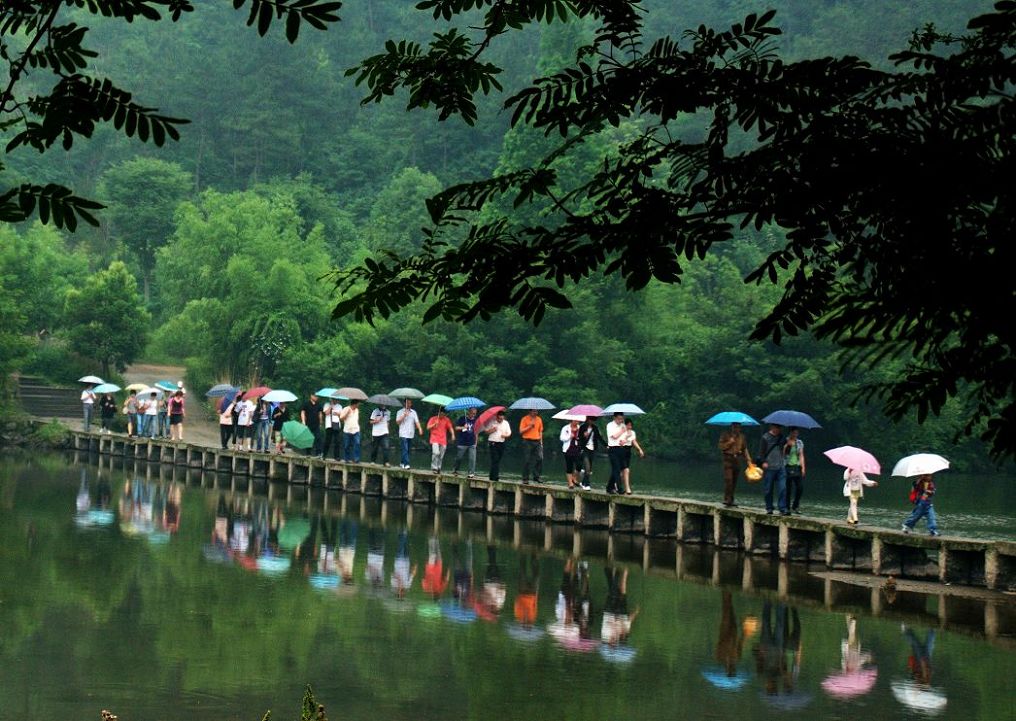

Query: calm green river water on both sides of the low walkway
<box><xmin>0</xmin><ymin>454</ymin><xmax>1016</xmax><ymax>721</ymax></box>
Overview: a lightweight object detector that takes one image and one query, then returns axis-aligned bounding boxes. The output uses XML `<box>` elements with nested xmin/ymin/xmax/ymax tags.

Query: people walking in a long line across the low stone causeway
<box><xmin>81</xmin><ymin>385</ymin><xmax>939</xmax><ymax>535</ymax></box>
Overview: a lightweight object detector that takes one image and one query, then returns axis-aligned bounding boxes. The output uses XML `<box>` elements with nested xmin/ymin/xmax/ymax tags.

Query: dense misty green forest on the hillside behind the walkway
<box><xmin>0</xmin><ymin>0</ymin><xmax>991</xmax><ymax>469</ymax></box>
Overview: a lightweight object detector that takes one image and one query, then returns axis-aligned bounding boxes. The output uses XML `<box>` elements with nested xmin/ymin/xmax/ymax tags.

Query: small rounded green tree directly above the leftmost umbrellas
<box><xmin>64</xmin><ymin>260</ymin><xmax>151</xmax><ymax>376</ymax></box>
